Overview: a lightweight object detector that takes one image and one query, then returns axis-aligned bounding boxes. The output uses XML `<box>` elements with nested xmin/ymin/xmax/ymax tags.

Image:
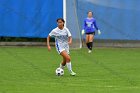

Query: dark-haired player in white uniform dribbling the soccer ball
<box><xmin>47</xmin><ymin>18</ymin><xmax>76</xmax><ymax>76</ymax></box>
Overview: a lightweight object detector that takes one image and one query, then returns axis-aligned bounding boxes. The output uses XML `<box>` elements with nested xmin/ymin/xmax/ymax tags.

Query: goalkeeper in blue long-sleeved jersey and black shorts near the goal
<box><xmin>82</xmin><ymin>11</ymin><xmax>101</xmax><ymax>53</ymax></box>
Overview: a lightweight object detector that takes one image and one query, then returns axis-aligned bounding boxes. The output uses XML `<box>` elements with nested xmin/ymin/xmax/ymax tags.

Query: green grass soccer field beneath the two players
<box><xmin>0</xmin><ymin>47</ymin><xmax>140</xmax><ymax>93</ymax></box>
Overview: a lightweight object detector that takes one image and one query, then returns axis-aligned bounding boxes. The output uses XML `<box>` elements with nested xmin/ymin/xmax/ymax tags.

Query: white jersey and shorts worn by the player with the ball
<box><xmin>49</xmin><ymin>27</ymin><xmax>71</xmax><ymax>54</ymax></box>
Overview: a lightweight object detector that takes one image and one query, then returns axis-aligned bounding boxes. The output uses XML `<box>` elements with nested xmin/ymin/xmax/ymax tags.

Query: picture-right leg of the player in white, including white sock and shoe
<box><xmin>61</xmin><ymin>51</ymin><xmax>76</xmax><ymax>76</ymax></box>
